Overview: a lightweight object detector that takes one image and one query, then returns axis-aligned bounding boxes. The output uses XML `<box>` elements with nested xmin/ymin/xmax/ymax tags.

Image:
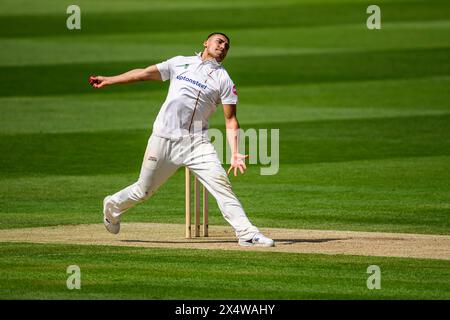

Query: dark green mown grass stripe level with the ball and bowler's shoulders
<box><xmin>0</xmin><ymin>48</ymin><xmax>450</xmax><ymax>97</ymax></box>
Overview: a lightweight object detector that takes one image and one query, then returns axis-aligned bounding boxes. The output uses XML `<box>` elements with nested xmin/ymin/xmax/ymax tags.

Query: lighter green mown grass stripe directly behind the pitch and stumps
<box><xmin>0</xmin><ymin>156</ymin><xmax>450</xmax><ymax>234</ymax></box>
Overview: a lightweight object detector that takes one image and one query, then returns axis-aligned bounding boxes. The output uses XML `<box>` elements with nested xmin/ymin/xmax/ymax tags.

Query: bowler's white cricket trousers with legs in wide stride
<box><xmin>109</xmin><ymin>134</ymin><xmax>259</xmax><ymax>240</ymax></box>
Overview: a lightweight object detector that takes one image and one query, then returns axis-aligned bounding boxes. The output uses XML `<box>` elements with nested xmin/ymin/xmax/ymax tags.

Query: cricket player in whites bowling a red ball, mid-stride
<box><xmin>89</xmin><ymin>32</ymin><xmax>274</xmax><ymax>247</ymax></box>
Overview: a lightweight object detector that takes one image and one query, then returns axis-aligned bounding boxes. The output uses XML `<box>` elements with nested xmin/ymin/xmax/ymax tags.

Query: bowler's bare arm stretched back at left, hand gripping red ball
<box><xmin>89</xmin><ymin>65</ymin><xmax>162</xmax><ymax>88</ymax></box>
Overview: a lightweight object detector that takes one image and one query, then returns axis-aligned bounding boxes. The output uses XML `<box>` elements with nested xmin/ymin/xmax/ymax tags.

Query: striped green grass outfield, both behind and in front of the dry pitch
<box><xmin>0</xmin><ymin>0</ymin><xmax>450</xmax><ymax>299</ymax></box>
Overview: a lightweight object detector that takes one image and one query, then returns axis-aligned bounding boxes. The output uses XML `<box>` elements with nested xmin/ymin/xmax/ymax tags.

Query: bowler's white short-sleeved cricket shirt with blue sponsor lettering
<box><xmin>153</xmin><ymin>54</ymin><xmax>238</xmax><ymax>139</ymax></box>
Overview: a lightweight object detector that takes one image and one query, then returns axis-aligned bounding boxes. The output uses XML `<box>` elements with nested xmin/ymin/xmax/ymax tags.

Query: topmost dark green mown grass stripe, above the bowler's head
<box><xmin>0</xmin><ymin>1</ymin><xmax>449</xmax><ymax>38</ymax></box>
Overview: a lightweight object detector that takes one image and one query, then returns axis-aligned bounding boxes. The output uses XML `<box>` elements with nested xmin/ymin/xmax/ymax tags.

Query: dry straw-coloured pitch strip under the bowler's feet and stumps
<box><xmin>0</xmin><ymin>223</ymin><xmax>450</xmax><ymax>260</ymax></box>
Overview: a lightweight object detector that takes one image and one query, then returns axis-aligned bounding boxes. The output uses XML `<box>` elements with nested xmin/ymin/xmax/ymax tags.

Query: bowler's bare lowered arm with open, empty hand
<box><xmin>223</xmin><ymin>104</ymin><xmax>248</xmax><ymax>176</ymax></box>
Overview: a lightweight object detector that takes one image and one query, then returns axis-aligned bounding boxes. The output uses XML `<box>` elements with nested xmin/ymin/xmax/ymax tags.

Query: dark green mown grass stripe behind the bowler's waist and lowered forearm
<box><xmin>0</xmin><ymin>114</ymin><xmax>450</xmax><ymax>176</ymax></box>
